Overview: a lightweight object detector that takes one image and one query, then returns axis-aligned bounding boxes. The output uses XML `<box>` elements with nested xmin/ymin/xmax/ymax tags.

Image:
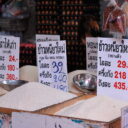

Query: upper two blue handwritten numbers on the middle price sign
<box><xmin>52</xmin><ymin>61</ymin><xmax>67</xmax><ymax>83</ymax></box>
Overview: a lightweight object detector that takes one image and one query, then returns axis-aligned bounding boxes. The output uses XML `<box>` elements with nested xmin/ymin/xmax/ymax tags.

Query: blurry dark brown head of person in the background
<box><xmin>78</xmin><ymin>15</ymin><xmax>100</xmax><ymax>45</ymax></box>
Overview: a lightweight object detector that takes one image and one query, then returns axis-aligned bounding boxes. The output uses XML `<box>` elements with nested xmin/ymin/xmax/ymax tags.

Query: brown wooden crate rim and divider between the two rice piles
<box><xmin>0</xmin><ymin>95</ymin><xmax>121</xmax><ymax>128</ymax></box>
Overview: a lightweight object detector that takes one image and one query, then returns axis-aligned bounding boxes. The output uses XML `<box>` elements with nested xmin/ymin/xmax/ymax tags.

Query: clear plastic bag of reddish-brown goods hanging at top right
<box><xmin>103</xmin><ymin>0</ymin><xmax>126</xmax><ymax>37</ymax></box>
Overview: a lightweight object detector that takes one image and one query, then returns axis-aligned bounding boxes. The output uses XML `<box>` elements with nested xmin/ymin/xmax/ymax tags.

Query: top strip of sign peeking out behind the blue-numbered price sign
<box><xmin>36</xmin><ymin>34</ymin><xmax>60</xmax><ymax>42</ymax></box>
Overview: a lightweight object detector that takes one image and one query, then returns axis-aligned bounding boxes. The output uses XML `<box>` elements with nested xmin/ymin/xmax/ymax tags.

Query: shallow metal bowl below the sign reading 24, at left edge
<box><xmin>0</xmin><ymin>80</ymin><xmax>28</xmax><ymax>91</ymax></box>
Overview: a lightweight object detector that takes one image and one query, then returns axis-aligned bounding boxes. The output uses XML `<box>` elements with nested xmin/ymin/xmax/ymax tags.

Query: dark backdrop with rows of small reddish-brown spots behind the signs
<box><xmin>1</xmin><ymin>0</ymin><xmax>124</xmax><ymax>72</ymax></box>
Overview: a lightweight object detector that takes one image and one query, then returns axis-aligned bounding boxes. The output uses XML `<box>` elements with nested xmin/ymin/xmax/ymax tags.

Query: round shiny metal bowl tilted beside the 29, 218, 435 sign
<box><xmin>73</xmin><ymin>73</ymin><xmax>97</xmax><ymax>92</ymax></box>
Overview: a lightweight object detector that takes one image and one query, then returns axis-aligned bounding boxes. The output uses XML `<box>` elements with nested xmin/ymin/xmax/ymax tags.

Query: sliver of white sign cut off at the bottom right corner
<box><xmin>121</xmin><ymin>106</ymin><xmax>128</xmax><ymax>128</ymax></box>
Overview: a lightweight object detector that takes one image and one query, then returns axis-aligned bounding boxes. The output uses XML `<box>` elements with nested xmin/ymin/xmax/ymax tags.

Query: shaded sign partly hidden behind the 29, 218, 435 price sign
<box><xmin>86</xmin><ymin>37</ymin><xmax>98</xmax><ymax>73</ymax></box>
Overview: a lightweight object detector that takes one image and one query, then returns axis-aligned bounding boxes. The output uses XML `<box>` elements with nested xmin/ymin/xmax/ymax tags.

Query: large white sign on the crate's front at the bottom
<box><xmin>12</xmin><ymin>112</ymin><xmax>84</xmax><ymax>128</ymax></box>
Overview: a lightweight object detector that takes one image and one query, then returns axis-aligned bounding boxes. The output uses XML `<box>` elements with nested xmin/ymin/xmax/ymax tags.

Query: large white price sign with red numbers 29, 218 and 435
<box><xmin>97</xmin><ymin>38</ymin><xmax>128</xmax><ymax>101</ymax></box>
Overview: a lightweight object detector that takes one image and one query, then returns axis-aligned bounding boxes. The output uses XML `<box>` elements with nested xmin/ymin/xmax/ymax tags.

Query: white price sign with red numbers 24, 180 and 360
<box><xmin>0</xmin><ymin>36</ymin><xmax>20</xmax><ymax>81</ymax></box>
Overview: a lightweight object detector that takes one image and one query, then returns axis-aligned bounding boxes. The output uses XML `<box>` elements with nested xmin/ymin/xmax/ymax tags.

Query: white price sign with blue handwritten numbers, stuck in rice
<box><xmin>36</xmin><ymin>41</ymin><xmax>68</xmax><ymax>91</ymax></box>
